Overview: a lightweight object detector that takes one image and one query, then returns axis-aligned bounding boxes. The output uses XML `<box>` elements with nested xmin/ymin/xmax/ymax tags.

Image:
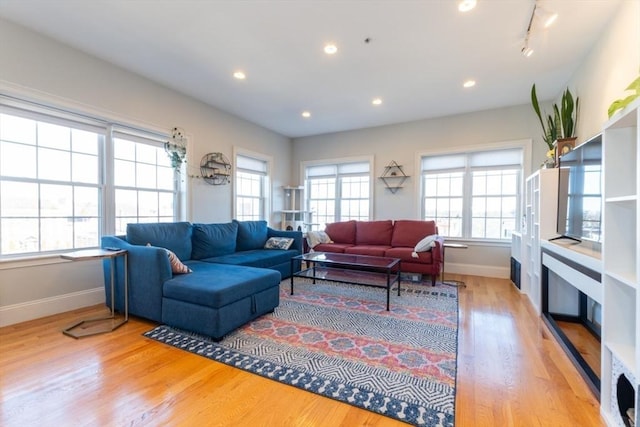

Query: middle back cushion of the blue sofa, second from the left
<box><xmin>191</xmin><ymin>222</ymin><xmax>238</xmax><ymax>259</ymax></box>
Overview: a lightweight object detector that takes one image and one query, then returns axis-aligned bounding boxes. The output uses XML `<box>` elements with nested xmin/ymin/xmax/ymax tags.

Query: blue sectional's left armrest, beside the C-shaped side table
<box><xmin>101</xmin><ymin>236</ymin><xmax>172</xmax><ymax>322</ymax></box>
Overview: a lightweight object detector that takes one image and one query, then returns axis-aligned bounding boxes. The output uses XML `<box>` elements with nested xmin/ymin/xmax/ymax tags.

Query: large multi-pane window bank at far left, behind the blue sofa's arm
<box><xmin>0</xmin><ymin>98</ymin><xmax>178</xmax><ymax>257</ymax></box>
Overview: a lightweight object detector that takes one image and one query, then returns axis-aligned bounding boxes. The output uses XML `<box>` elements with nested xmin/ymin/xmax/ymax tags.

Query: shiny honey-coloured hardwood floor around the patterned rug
<box><xmin>0</xmin><ymin>274</ymin><xmax>605</xmax><ymax>427</ymax></box>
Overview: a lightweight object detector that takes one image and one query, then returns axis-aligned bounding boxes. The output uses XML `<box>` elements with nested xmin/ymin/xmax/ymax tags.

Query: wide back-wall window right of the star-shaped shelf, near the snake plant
<box><xmin>422</xmin><ymin>148</ymin><xmax>523</xmax><ymax>239</ymax></box>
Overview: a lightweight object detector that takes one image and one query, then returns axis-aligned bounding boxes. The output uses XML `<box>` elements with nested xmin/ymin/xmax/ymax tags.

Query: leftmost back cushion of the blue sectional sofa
<box><xmin>127</xmin><ymin>222</ymin><xmax>191</xmax><ymax>261</ymax></box>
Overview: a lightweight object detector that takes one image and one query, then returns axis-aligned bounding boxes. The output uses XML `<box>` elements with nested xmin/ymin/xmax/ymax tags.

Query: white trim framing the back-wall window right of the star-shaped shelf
<box><xmin>414</xmin><ymin>139</ymin><xmax>533</xmax><ymax>242</ymax></box>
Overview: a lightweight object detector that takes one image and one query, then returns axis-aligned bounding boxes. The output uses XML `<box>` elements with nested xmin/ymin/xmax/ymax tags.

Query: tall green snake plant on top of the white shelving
<box><xmin>531</xmin><ymin>84</ymin><xmax>580</xmax><ymax>166</ymax></box>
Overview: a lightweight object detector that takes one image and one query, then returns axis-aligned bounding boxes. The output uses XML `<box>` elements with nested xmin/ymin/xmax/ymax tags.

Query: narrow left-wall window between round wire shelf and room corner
<box><xmin>235</xmin><ymin>154</ymin><xmax>268</xmax><ymax>221</ymax></box>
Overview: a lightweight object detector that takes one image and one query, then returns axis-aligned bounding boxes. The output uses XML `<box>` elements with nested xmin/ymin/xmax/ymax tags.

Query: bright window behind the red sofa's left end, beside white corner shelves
<box><xmin>305</xmin><ymin>162</ymin><xmax>371</xmax><ymax>230</ymax></box>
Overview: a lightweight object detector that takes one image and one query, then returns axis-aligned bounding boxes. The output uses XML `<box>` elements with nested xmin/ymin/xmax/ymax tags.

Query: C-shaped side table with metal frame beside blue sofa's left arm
<box><xmin>60</xmin><ymin>249</ymin><xmax>129</xmax><ymax>338</ymax></box>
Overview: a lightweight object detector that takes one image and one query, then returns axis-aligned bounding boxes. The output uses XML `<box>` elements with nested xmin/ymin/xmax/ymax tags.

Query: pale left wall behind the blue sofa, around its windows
<box><xmin>0</xmin><ymin>19</ymin><xmax>291</xmax><ymax>326</ymax></box>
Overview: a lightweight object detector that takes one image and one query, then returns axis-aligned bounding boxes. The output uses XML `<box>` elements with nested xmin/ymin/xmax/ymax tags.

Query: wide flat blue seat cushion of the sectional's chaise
<box><xmin>163</xmin><ymin>261</ymin><xmax>280</xmax><ymax>308</ymax></box>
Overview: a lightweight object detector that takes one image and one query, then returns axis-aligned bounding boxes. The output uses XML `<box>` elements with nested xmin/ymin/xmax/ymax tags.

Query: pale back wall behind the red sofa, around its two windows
<box><xmin>292</xmin><ymin>105</ymin><xmax>546</xmax><ymax>278</ymax></box>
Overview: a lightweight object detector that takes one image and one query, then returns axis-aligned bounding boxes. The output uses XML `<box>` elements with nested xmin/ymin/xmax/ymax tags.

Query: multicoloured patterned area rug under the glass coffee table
<box><xmin>144</xmin><ymin>279</ymin><xmax>458</xmax><ymax>426</ymax></box>
